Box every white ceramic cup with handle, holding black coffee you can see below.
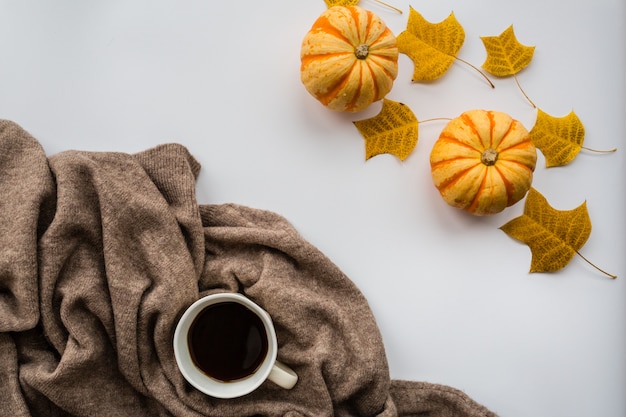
[174,293,298,398]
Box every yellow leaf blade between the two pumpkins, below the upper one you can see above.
[353,99,418,161]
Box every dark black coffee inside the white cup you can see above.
[187,301,267,381]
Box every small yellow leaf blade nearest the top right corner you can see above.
[481,25,535,77]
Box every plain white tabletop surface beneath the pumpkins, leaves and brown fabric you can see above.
[0,0,626,417]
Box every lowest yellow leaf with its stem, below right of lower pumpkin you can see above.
[500,188,616,278]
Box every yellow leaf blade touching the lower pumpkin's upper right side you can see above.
[530,109,585,167]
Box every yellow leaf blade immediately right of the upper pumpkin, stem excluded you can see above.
[398,7,465,82]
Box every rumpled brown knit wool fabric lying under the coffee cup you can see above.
[0,121,495,417]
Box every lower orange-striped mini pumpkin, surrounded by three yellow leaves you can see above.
[430,110,537,216]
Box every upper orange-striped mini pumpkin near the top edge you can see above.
[300,6,398,112]
